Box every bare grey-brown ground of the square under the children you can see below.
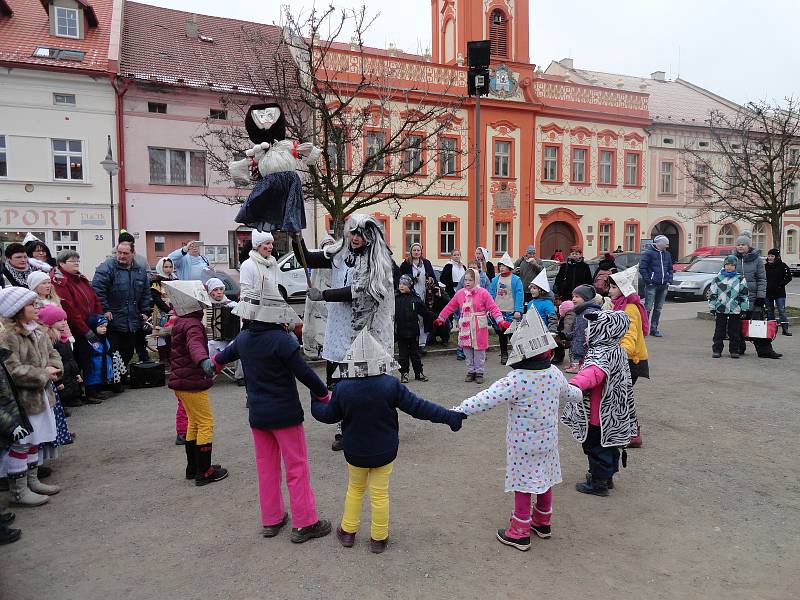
[0,320,800,600]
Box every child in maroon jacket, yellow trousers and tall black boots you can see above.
[164,281,228,486]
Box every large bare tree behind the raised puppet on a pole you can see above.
[195,6,469,237]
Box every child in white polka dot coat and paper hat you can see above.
[454,310,581,551]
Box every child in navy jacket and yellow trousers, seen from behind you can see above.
[311,330,466,554]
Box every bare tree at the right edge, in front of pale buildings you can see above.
[682,98,800,248]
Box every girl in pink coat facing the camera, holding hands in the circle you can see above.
[434,269,510,384]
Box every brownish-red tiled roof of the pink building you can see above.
[119,1,292,95]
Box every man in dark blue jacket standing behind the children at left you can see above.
[92,242,152,365]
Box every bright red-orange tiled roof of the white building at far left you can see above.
[0,0,115,72]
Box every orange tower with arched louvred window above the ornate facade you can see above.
[431,0,530,65]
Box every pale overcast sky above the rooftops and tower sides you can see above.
[145,0,800,102]
